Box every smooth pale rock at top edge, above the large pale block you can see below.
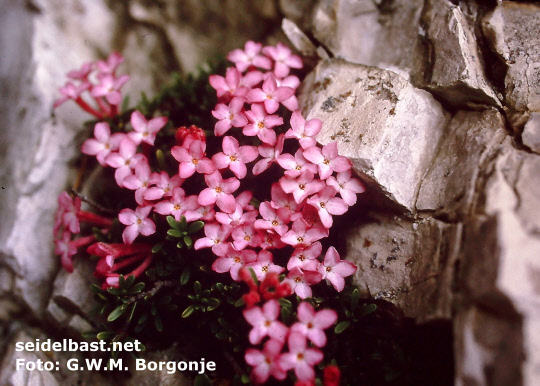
[312,0,428,80]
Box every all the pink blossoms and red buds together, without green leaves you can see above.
[53,42,364,384]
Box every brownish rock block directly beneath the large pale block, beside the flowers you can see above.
[344,215,461,322]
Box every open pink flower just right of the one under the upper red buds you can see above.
[212,137,259,179]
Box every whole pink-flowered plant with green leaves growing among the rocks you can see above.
[50,41,396,385]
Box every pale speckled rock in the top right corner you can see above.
[483,1,540,111]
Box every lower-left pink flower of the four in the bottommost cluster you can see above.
[245,339,287,384]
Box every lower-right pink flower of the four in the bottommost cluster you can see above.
[279,332,323,382]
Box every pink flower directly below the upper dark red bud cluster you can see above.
[171,140,216,178]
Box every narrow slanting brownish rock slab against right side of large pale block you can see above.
[416,110,506,219]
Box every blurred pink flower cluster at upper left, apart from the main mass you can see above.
[54,53,129,119]
